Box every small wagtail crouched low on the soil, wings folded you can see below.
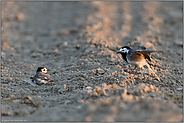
[30,67,50,85]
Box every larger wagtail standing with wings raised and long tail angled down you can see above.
[117,46,160,81]
